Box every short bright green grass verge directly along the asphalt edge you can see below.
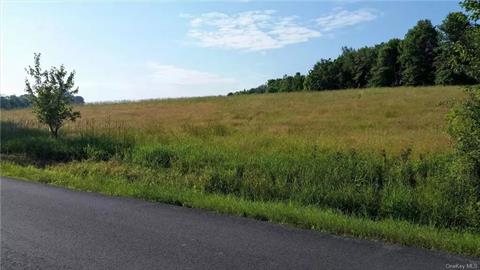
[1,162,480,257]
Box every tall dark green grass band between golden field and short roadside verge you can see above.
[1,123,480,232]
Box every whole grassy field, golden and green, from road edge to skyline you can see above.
[1,87,480,256]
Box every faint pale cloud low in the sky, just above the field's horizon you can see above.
[148,63,235,85]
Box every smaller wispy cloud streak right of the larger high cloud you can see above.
[316,9,378,31]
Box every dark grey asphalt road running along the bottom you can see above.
[0,178,480,270]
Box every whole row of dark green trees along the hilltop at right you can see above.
[228,9,480,95]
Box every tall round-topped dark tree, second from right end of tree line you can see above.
[400,20,438,85]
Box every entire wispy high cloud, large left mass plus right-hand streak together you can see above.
[181,9,378,51]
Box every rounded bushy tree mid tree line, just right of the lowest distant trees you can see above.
[305,59,340,91]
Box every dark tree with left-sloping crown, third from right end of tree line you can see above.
[369,39,401,86]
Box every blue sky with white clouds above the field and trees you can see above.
[0,1,461,102]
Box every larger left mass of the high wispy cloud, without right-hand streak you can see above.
[188,10,321,51]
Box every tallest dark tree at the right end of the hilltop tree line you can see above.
[435,12,475,85]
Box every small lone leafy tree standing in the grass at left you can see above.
[25,53,80,137]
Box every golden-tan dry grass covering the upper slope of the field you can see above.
[1,86,463,153]
